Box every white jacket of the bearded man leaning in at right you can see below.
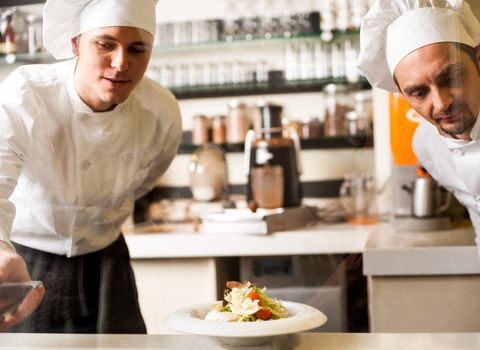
[413,117,480,250]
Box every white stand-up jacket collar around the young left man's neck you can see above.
[67,58,133,118]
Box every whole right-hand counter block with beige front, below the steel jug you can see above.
[363,227,480,332]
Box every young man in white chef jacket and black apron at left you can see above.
[0,0,181,333]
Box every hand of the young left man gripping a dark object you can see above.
[0,241,45,332]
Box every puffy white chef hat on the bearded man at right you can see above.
[357,0,480,91]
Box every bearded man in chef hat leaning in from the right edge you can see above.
[357,0,480,258]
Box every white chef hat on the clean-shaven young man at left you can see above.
[43,0,158,59]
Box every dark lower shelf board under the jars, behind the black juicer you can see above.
[178,131,373,154]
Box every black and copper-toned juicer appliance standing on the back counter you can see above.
[245,104,302,209]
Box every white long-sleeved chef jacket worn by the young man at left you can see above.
[0,59,182,256]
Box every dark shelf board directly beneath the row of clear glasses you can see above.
[170,78,371,100]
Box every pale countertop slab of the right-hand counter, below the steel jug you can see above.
[363,225,480,276]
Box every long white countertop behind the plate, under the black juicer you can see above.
[125,223,372,259]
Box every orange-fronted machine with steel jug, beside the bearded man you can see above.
[389,93,451,231]
